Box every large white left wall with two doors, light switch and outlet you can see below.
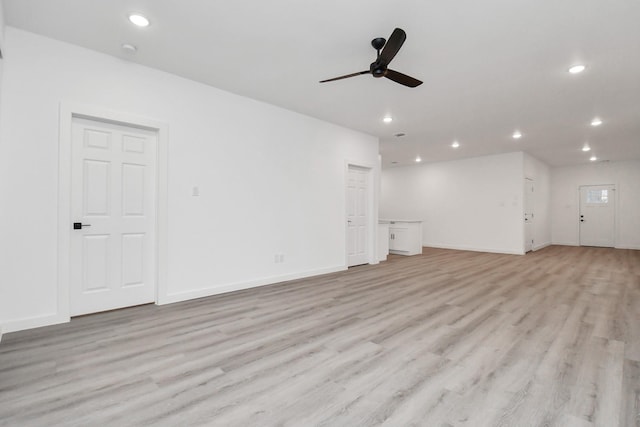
[0,27,379,331]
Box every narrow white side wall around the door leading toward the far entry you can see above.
[524,153,551,250]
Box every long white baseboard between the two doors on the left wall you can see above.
[158,265,347,305]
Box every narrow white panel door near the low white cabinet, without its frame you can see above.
[347,165,369,267]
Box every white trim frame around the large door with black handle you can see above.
[56,102,169,322]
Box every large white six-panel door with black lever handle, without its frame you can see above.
[69,118,157,316]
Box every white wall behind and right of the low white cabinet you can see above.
[380,152,524,254]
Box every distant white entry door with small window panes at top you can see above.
[580,185,615,247]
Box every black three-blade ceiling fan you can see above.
[320,28,422,87]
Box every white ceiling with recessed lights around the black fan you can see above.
[3,0,640,167]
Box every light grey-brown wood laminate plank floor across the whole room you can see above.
[0,246,640,427]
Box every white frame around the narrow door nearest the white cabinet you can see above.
[343,160,380,268]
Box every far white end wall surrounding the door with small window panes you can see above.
[551,160,640,249]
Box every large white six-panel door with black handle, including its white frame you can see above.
[58,102,168,323]
